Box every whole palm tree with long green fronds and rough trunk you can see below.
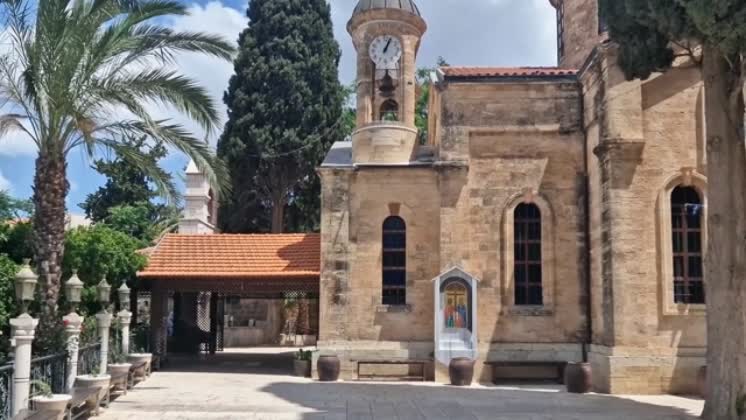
[0,0,234,323]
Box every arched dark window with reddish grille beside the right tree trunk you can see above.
[671,187,705,304]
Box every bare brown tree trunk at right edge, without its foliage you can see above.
[703,46,746,420]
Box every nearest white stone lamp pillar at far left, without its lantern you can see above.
[10,314,39,417]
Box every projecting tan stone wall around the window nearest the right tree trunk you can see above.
[582,47,706,393]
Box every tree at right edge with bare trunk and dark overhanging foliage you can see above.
[601,0,746,420]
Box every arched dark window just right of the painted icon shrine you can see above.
[513,203,544,305]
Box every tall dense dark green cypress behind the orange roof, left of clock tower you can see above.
[218,0,344,232]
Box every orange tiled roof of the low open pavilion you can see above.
[137,234,321,279]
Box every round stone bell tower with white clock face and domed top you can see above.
[347,0,427,165]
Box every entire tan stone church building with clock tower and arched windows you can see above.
[319,0,707,393]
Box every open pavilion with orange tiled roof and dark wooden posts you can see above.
[137,234,320,356]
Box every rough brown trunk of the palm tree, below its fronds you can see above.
[33,150,69,323]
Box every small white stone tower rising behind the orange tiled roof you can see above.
[179,160,217,235]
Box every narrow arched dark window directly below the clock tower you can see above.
[383,216,407,305]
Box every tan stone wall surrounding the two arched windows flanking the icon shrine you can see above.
[319,80,585,381]
